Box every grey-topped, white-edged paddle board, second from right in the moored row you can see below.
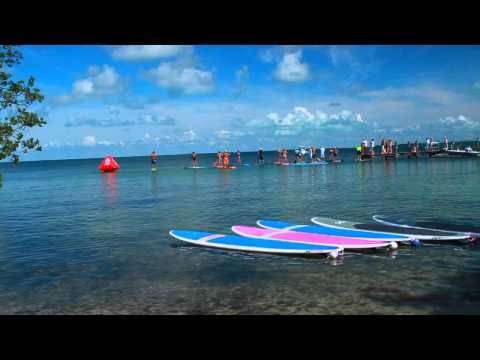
[311,217,470,241]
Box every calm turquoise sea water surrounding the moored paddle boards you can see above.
[0,152,480,314]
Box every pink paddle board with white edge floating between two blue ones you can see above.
[232,225,398,249]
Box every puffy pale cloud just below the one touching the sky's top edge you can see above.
[143,62,214,95]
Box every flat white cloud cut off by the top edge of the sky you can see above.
[110,45,193,61]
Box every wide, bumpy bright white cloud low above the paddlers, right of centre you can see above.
[246,106,366,135]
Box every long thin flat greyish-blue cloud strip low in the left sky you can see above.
[65,114,176,127]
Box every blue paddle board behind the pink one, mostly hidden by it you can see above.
[257,220,410,241]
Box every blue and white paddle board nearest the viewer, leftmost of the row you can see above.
[170,229,343,258]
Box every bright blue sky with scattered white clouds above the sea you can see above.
[6,45,480,160]
